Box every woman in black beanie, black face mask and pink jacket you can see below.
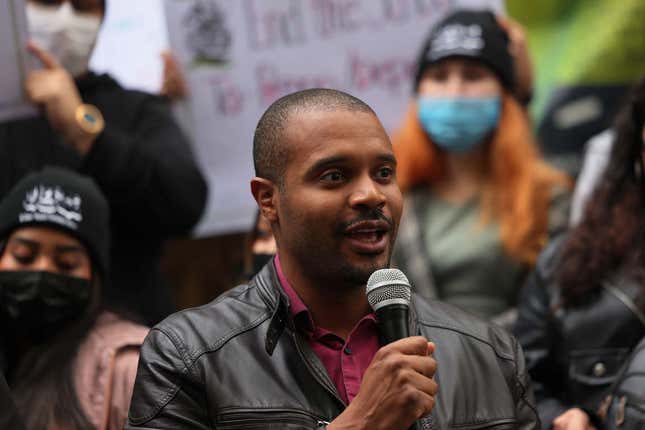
[0,167,148,430]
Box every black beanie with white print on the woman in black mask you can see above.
[0,167,110,276]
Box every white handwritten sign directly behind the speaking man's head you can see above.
[164,0,503,235]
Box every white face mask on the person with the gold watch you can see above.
[27,2,101,77]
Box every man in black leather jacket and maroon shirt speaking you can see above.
[126,89,539,430]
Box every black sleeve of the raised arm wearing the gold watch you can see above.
[81,95,207,236]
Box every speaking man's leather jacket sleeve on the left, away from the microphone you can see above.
[125,328,212,430]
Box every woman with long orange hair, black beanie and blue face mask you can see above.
[393,10,569,323]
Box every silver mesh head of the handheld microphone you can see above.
[366,269,412,312]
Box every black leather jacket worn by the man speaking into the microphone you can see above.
[126,263,539,430]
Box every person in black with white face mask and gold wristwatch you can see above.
[0,0,207,324]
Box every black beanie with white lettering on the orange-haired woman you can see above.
[414,10,515,92]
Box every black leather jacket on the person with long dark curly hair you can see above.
[514,235,645,429]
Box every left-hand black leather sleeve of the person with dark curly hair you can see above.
[514,236,567,429]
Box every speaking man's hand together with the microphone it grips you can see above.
[328,269,438,430]
